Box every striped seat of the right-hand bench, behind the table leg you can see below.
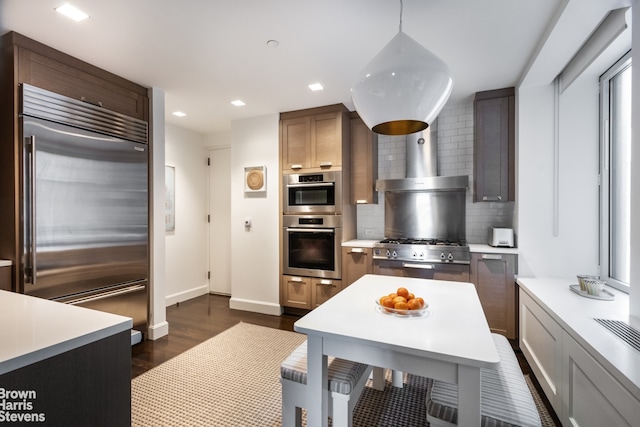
[427,334,541,427]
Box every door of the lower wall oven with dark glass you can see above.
[282,227,342,279]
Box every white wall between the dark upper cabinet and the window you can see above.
[517,72,599,279]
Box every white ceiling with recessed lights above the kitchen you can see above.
[0,0,620,134]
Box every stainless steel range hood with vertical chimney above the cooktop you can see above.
[376,126,469,192]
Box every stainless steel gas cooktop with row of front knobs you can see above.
[373,238,471,264]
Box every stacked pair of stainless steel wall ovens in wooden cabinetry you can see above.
[282,171,342,279]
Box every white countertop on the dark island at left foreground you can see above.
[0,291,133,375]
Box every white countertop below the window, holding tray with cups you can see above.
[517,277,640,399]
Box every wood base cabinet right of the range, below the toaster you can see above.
[469,253,517,339]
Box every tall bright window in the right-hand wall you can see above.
[600,52,631,292]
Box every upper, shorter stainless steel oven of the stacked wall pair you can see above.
[282,172,342,214]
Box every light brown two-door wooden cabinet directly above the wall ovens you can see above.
[280,104,349,174]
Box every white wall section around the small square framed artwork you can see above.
[230,114,281,315]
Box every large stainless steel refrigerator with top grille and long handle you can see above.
[20,84,149,330]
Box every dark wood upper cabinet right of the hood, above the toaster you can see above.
[473,88,515,202]
